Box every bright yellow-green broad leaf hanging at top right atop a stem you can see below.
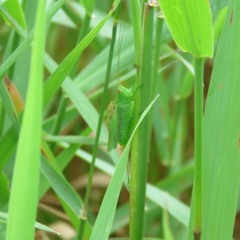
[159,0,213,58]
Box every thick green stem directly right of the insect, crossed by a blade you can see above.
[130,5,153,239]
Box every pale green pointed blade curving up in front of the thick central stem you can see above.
[90,96,158,240]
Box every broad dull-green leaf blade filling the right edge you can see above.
[189,0,240,240]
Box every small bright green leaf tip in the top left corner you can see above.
[1,0,26,29]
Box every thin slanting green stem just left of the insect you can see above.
[78,7,119,240]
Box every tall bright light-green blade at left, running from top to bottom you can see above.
[7,0,45,240]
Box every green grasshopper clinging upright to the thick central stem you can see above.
[107,85,134,150]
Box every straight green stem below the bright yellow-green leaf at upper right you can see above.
[193,59,204,240]
